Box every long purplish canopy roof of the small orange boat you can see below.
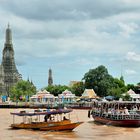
[10,109,72,116]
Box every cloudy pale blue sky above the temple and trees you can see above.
[0,0,140,89]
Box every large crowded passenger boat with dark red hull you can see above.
[88,101,140,127]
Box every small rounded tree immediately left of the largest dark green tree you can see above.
[71,82,85,96]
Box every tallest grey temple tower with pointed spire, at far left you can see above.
[0,24,22,96]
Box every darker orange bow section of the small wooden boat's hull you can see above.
[40,122,83,131]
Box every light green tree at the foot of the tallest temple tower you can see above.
[10,80,36,101]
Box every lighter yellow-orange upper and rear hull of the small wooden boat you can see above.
[11,120,71,129]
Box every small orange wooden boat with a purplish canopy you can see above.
[11,109,83,131]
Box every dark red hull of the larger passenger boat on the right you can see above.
[93,116,140,127]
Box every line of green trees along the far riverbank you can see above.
[10,65,140,100]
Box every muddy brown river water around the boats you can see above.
[0,109,140,140]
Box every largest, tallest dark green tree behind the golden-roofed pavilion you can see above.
[83,65,113,96]
